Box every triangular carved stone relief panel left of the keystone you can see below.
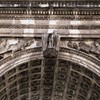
[0,38,42,59]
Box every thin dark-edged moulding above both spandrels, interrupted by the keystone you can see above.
[0,32,100,40]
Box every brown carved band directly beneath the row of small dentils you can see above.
[0,14,100,21]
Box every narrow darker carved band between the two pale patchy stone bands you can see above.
[0,24,100,30]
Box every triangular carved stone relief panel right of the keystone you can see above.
[60,39,100,59]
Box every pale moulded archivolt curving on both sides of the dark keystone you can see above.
[0,48,100,76]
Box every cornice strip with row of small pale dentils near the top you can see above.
[0,8,100,16]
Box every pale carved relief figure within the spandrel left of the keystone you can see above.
[0,39,33,54]
